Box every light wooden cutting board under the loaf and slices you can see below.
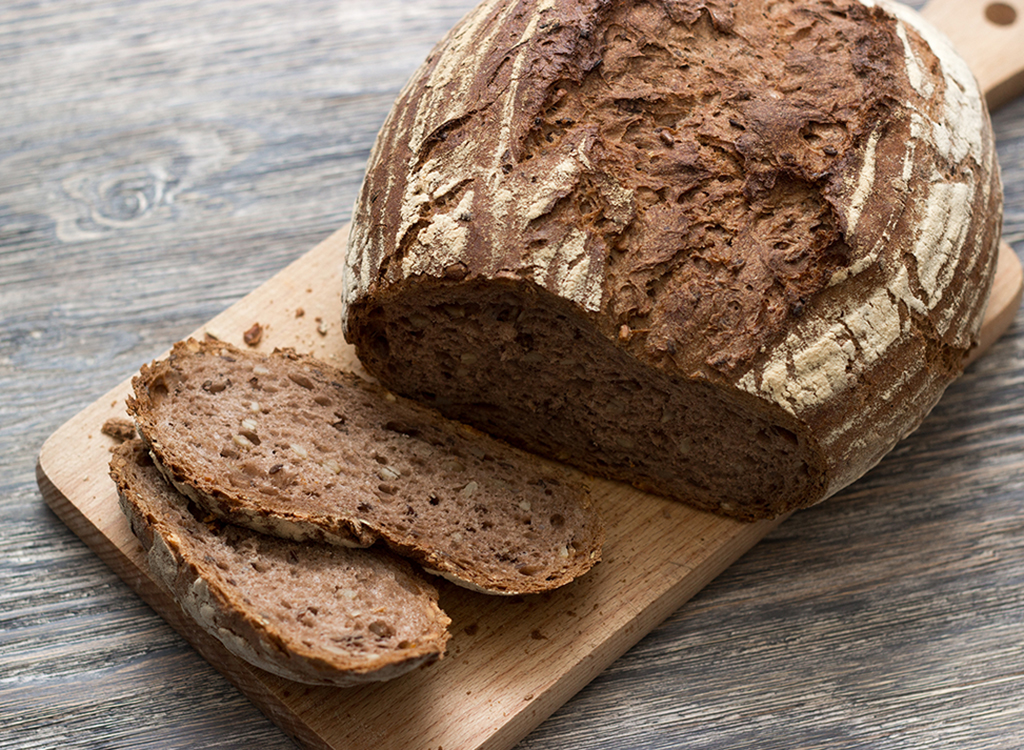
[37,0,1024,750]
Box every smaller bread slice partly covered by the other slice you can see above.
[111,439,451,686]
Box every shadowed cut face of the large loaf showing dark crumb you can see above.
[352,283,825,518]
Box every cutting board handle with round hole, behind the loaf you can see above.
[921,0,1024,110]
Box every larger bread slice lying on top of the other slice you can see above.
[128,340,604,594]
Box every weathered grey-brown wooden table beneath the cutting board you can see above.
[0,0,1024,750]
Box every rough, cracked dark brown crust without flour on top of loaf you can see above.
[515,1,901,373]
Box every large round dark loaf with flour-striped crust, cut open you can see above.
[344,0,1001,519]
